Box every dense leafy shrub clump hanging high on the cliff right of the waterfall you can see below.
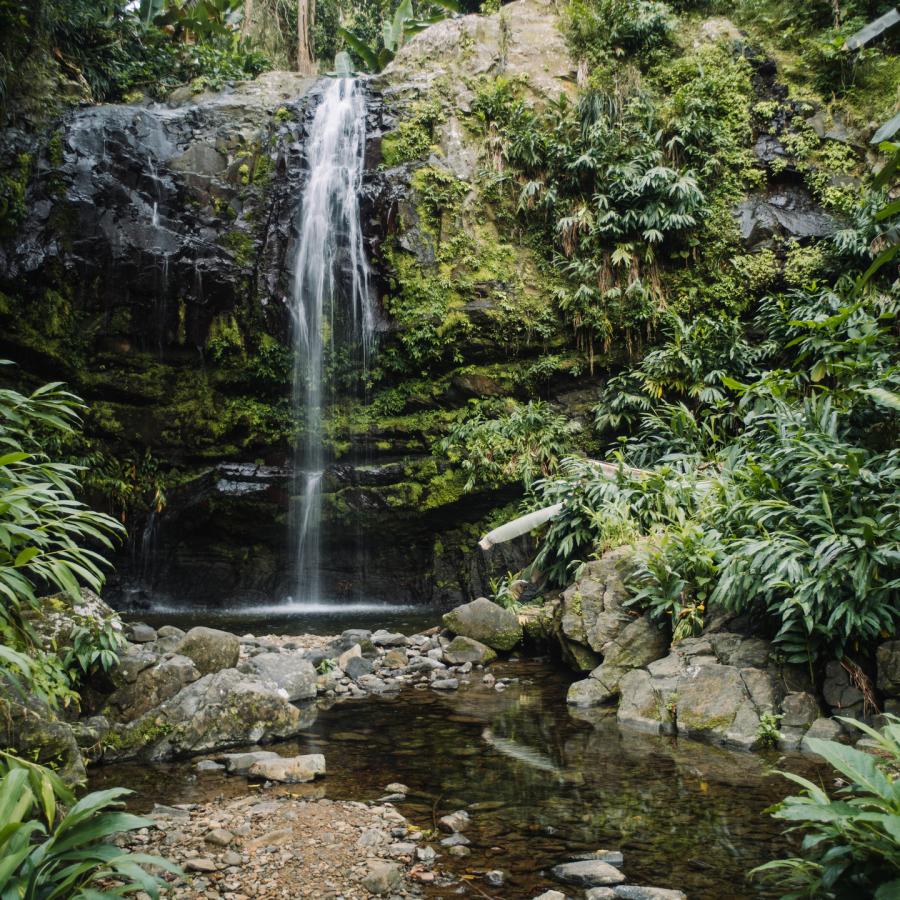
[474,82,704,360]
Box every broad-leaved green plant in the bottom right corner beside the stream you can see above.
[750,715,900,900]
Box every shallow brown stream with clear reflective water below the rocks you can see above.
[92,614,816,900]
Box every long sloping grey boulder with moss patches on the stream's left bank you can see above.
[104,669,315,761]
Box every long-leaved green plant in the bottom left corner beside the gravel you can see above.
[0,753,179,900]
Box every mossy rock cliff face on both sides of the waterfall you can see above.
[0,0,840,605]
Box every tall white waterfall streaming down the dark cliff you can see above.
[291,78,374,604]
